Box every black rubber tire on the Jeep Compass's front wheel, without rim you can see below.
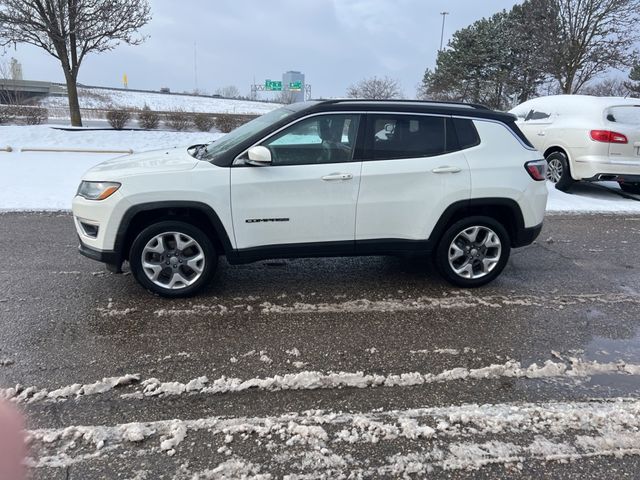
[129,221,218,298]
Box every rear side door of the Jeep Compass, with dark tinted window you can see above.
[356,113,471,241]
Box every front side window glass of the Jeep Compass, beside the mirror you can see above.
[262,114,360,165]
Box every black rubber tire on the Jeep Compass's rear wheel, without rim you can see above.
[434,216,511,288]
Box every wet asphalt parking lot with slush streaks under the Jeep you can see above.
[0,213,640,480]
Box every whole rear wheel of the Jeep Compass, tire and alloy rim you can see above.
[435,216,511,288]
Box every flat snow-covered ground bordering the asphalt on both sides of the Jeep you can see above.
[0,125,640,213]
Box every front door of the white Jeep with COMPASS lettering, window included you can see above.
[231,114,361,249]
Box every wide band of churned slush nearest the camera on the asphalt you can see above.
[27,399,640,480]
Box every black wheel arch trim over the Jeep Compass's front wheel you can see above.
[114,201,233,262]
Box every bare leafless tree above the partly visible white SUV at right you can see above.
[548,0,640,93]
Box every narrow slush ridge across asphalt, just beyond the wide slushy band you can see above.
[5,358,640,403]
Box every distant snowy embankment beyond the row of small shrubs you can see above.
[40,88,281,114]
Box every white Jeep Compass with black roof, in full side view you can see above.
[73,100,547,297]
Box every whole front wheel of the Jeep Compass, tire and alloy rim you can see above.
[129,221,218,298]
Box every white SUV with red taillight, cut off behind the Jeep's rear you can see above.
[511,95,640,194]
